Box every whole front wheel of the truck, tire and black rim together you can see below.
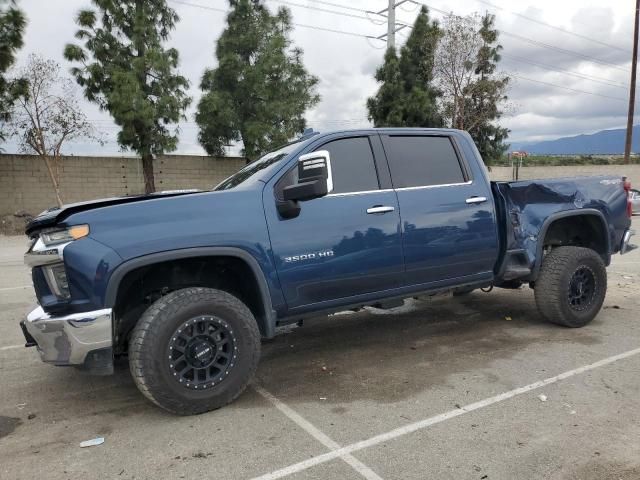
[129,288,260,415]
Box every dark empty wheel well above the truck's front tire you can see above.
[114,256,266,353]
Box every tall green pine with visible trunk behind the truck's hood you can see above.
[64,0,191,193]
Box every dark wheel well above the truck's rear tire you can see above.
[543,215,609,263]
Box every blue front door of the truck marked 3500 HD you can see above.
[264,135,404,313]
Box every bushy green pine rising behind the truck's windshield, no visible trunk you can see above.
[196,0,320,160]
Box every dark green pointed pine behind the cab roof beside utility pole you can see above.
[367,6,442,127]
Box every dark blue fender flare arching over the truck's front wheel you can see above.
[105,247,276,338]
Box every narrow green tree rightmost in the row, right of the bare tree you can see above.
[465,13,509,163]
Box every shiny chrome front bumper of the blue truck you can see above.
[22,307,113,374]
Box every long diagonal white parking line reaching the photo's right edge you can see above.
[253,348,640,480]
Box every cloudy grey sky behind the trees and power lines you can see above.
[4,0,634,155]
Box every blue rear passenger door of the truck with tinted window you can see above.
[382,134,498,285]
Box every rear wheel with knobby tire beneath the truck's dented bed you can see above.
[535,247,607,328]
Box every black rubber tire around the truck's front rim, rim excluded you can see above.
[129,287,260,415]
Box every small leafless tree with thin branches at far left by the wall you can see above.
[11,54,102,206]
